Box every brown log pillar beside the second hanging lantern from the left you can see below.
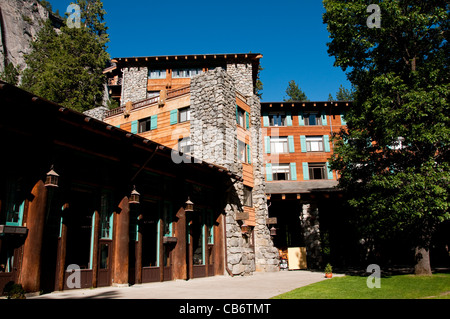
[113,196,130,286]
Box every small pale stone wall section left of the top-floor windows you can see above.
[121,67,148,105]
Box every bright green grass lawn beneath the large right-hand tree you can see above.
[273,274,450,299]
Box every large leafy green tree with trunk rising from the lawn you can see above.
[323,0,450,274]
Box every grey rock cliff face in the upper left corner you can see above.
[0,0,49,72]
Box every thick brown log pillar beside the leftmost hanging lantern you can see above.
[20,180,47,292]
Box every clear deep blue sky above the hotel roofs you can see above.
[50,0,350,102]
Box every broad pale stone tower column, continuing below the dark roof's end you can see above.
[190,68,255,275]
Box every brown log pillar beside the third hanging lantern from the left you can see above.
[172,207,187,280]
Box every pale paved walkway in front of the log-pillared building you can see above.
[28,270,340,299]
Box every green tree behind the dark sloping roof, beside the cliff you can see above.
[22,0,109,112]
